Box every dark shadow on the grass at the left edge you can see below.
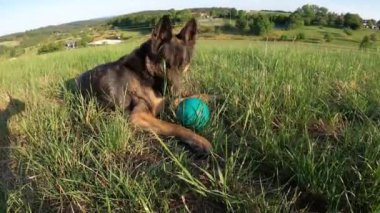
[0,96,25,212]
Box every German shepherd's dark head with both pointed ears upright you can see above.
[146,16,197,93]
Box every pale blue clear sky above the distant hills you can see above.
[0,0,380,35]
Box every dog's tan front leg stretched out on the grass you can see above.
[130,102,211,153]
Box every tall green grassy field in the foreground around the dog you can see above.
[0,41,380,212]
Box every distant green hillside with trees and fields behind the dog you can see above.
[0,5,380,59]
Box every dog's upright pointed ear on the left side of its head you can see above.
[152,15,172,50]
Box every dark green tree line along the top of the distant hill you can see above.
[108,4,380,35]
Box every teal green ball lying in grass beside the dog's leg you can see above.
[176,98,210,131]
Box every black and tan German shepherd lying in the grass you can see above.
[76,16,211,153]
